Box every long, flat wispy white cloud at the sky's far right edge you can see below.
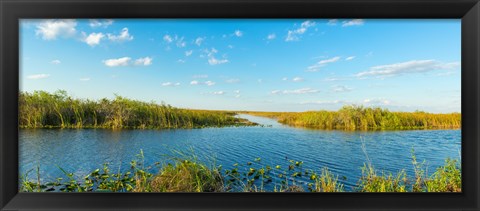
[356,60,460,77]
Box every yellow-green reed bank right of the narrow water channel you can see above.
[244,106,461,130]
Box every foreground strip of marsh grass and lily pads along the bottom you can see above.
[19,149,462,192]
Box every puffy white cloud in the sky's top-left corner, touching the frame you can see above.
[35,19,77,40]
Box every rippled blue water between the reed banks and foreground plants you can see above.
[19,115,461,190]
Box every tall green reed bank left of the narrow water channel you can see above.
[19,91,254,129]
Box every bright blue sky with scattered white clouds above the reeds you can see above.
[20,19,461,113]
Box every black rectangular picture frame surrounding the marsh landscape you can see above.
[0,0,480,210]
